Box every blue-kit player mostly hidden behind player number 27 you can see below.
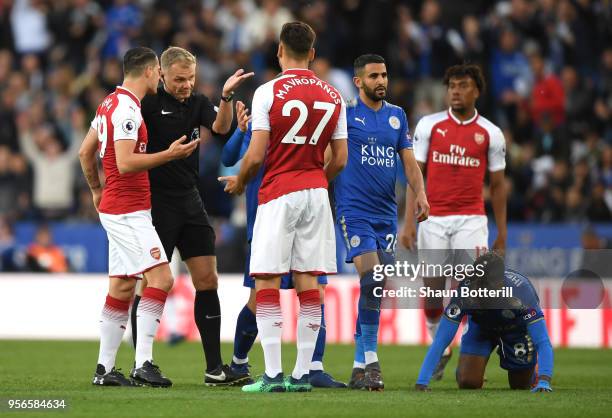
[221,102,346,388]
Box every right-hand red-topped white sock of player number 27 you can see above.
[291,289,321,379]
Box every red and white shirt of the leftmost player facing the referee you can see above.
[91,86,151,215]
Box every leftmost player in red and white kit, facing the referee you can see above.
[79,47,197,387]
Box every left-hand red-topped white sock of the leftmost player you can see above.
[98,295,130,372]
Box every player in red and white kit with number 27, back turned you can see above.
[221,22,348,392]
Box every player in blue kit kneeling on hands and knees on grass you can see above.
[415,252,553,392]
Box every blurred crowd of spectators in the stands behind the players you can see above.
[0,0,612,247]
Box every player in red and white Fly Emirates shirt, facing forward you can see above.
[400,64,506,379]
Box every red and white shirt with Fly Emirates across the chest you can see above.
[413,109,506,216]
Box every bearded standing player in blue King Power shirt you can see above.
[334,54,429,391]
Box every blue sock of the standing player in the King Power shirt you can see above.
[359,271,384,365]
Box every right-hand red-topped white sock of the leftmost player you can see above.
[136,287,168,368]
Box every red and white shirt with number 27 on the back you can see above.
[252,69,348,205]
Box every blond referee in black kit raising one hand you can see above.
[132,47,253,386]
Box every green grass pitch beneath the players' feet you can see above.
[0,340,612,418]
